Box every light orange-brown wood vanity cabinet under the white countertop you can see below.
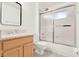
[0,35,33,57]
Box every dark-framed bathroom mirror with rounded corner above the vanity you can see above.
[1,2,22,26]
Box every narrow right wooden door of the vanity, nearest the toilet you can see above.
[24,43,33,57]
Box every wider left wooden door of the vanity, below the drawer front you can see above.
[3,47,23,57]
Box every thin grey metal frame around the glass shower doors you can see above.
[39,4,76,47]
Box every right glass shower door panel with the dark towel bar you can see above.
[54,6,76,46]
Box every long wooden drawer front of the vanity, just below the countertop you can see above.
[3,36,33,50]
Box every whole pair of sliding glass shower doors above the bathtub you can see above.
[40,5,76,47]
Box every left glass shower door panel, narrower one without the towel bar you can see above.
[40,12,53,42]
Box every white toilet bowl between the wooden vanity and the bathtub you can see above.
[35,41,47,55]
